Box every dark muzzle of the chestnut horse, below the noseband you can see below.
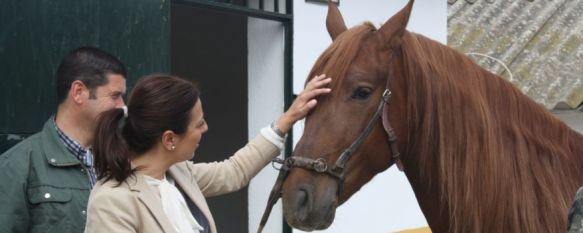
[282,174,338,231]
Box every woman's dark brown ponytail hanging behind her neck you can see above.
[93,109,132,185]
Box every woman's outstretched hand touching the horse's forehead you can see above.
[276,74,332,134]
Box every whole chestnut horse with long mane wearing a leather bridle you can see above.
[281,0,583,233]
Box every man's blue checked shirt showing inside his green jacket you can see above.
[53,120,97,187]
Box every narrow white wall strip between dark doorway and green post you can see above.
[247,18,284,233]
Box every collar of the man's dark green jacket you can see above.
[41,118,81,167]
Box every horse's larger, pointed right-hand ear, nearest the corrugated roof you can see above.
[379,0,415,46]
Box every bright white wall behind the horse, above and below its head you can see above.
[292,0,447,233]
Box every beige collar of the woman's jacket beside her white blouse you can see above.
[125,173,176,232]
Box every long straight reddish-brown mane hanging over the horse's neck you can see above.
[396,32,583,232]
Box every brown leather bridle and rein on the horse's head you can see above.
[257,88,402,233]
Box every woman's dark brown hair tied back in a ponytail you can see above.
[93,74,199,183]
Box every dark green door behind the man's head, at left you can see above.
[0,0,170,154]
